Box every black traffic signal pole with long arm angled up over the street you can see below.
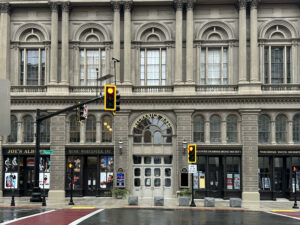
[30,95,103,202]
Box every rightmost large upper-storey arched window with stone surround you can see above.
[260,20,297,84]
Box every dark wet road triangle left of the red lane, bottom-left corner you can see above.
[0,208,47,223]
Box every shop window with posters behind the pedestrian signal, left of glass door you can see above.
[66,156,82,190]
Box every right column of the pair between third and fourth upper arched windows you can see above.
[186,0,194,83]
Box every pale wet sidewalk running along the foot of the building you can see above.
[0,197,300,211]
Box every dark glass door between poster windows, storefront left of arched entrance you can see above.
[84,156,97,196]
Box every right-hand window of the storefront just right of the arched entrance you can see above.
[226,156,241,190]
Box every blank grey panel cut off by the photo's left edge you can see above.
[0,79,10,136]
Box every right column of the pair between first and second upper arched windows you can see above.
[61,2,70,85]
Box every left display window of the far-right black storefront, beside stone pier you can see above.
[258,156,271,191]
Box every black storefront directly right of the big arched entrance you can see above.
[193,149,242,199]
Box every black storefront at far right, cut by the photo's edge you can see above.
[258,150,300,200]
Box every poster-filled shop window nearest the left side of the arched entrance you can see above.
[100,156,114,189]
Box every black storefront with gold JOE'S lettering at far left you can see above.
[2,148,51,196]
